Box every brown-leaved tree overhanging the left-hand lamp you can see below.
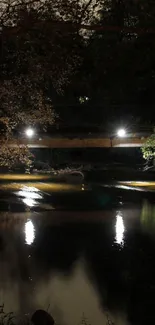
[0,0,99,165]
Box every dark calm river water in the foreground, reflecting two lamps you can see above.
[0,184,155,325]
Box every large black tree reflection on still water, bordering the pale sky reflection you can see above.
[34,213,155,324]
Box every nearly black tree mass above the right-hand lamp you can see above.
[60,0,155,123]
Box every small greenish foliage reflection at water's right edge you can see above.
[141,200,155,233]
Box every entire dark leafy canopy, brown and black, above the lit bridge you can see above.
[0,0,155,164]
